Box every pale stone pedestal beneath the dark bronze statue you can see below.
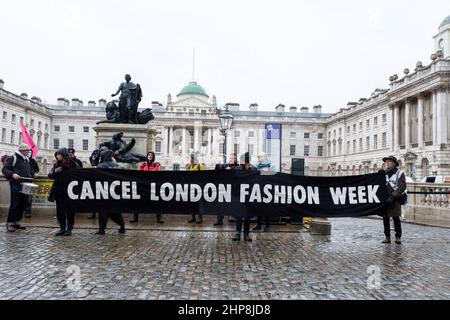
[94,123,159,169]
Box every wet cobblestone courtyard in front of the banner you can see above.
[0,217,450,299]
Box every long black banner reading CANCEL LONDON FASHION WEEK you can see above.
[54,169,387,217]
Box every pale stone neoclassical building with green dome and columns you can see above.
[0,16,450,180]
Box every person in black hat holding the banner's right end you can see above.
[380,156,406,244]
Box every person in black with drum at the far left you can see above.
[2,144,37,232]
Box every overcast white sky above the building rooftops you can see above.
[0,0,450,112]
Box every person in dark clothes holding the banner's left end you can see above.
[48,148,78,237]
